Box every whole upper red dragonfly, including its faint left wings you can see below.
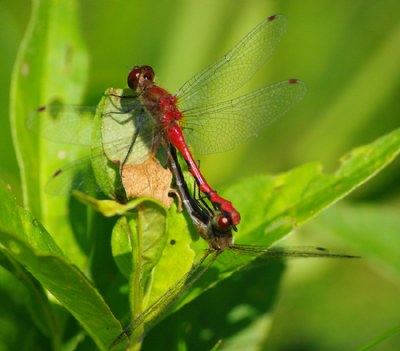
[32,15,306,230]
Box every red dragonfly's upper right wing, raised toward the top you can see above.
[176,15,287,112]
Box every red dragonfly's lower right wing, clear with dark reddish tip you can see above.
[184,79,307,154]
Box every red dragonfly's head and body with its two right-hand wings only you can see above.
[128,15,305,226]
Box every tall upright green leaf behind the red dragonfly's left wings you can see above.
[11,0,88,268]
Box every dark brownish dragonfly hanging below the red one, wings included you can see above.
[111,145,359,348]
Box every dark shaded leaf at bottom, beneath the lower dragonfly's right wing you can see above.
[144,260,285,350]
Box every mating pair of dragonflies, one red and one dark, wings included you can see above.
[34,15,353,346]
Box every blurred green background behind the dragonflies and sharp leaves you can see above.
[0,0,400,350]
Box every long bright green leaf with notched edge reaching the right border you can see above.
[170,129,400,314]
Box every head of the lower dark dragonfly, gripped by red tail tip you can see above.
[207,211,233,250]
